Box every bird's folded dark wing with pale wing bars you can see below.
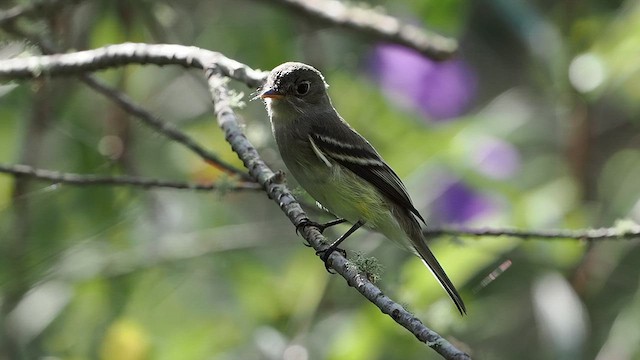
[309,119,425,223]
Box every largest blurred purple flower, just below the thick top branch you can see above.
[370,45,477,120]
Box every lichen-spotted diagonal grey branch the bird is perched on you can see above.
[206,68,470,359]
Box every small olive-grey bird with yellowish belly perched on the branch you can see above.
[258,62,466,315]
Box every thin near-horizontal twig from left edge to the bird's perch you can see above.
[0,164,261,191]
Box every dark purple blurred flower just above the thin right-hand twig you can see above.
[431,180,496,224]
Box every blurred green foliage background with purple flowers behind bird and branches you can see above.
[0,0,640,360]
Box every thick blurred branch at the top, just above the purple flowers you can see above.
[263,0,458,60]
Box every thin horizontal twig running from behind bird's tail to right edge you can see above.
[424,225,640,241]
